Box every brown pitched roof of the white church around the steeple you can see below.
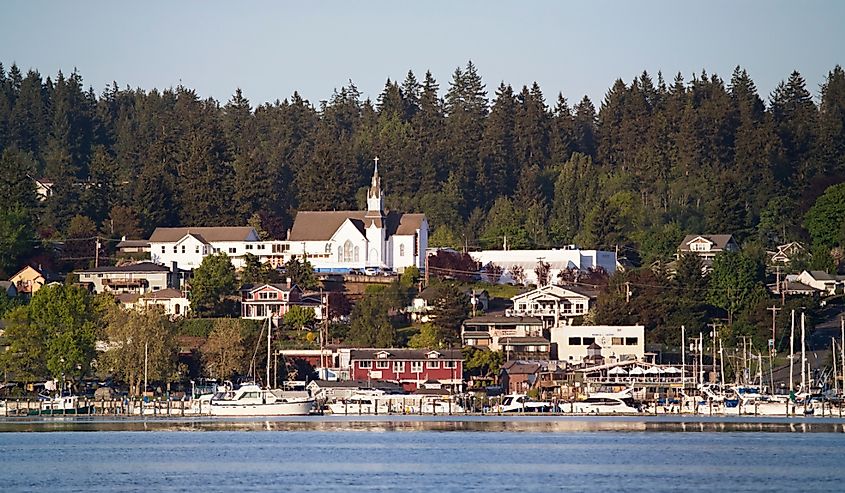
[288,211,425,241]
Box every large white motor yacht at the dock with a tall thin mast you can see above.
[206,317,315,416]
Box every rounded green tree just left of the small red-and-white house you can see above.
[191,252,235,316]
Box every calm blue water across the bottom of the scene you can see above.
[0,418,845,492]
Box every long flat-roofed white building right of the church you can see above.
[468,245,617,285]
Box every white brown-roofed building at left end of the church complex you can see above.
[150,226,258,270]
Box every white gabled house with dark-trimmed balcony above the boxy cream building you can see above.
[505,284,598,328]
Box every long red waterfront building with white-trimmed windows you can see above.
[349,348,464,391]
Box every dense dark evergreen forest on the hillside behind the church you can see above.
[0,62,845,270]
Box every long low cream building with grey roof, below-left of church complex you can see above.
[76,262,187,294]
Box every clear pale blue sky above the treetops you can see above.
[0,0,845,106]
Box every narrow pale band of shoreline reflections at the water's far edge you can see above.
[0,416,845,433]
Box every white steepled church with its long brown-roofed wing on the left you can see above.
[150,158,428,272]
